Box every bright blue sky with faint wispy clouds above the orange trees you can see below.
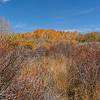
[0,0,100,32]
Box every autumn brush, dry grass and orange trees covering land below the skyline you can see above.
[0,30,100,100]
